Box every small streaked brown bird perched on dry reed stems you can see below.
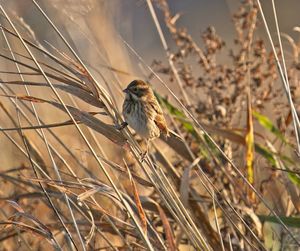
[123,80,169,156]
